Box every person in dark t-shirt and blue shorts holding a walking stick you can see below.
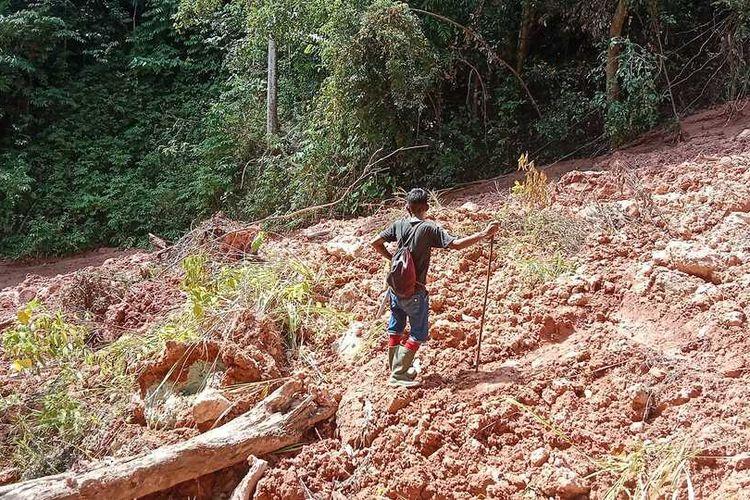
[371,188,499,387]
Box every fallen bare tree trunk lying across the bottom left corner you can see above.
[0,378,336,500]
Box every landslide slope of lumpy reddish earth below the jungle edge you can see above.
[0,101,750,499]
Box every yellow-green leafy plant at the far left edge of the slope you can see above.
[2,300,86,371]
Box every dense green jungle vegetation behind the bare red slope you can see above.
[0,0,750,257]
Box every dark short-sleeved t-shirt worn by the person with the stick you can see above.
[380,217,456,290]
